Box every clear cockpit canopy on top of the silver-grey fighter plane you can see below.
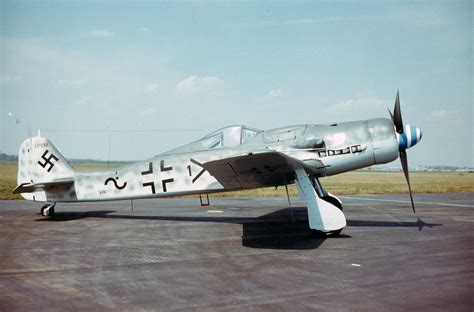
[161,125,262,154]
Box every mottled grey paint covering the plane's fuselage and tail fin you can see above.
[18,118,398,202]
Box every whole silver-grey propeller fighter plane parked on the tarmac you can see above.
[13,92,422,235]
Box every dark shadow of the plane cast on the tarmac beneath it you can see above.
[36,207,442,250]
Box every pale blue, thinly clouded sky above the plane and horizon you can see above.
[0,1,474,166]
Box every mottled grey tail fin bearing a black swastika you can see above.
[14,133,74,199]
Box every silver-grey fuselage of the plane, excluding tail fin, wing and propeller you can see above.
[45,118,399,202]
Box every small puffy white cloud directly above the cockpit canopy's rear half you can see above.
[176,76,224,96]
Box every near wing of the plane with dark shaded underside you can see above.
[202,150,325,189]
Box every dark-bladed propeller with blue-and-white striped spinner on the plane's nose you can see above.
[388,90,423,213]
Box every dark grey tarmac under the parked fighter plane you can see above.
[0,193,474,311]
